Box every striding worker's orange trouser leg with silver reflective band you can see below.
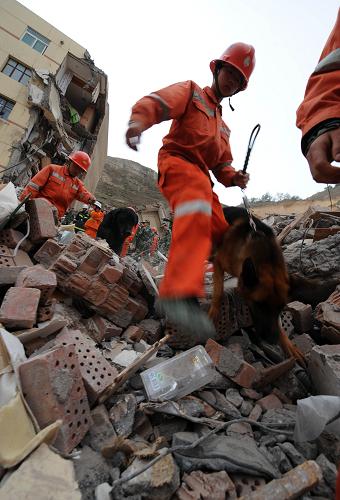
[159,157,227,298]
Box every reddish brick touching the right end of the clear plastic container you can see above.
[205,339,257,389]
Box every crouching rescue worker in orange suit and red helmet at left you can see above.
[20,151,96,219]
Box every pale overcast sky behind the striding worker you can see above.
[21,0,339,204]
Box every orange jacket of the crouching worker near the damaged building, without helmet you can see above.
[20,164,94,218]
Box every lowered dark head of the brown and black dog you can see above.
[239,235,289,343]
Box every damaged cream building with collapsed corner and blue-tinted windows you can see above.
[0,0,109,191]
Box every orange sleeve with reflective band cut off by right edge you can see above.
[296,10,340,144]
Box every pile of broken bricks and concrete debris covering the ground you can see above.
[0,199,340,500]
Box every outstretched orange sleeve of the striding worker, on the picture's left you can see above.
[129,80,193,130]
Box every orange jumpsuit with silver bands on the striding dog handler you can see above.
[130,80,235,298]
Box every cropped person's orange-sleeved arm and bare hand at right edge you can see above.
[296,10,340,184]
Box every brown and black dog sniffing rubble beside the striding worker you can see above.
[209,207,303,362]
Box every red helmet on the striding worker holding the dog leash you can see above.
[210,42,255,90]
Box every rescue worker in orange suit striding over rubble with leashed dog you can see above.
[126,43,255,342]
